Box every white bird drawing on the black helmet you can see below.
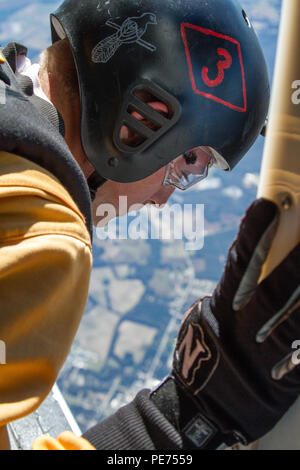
[92,13,157,64]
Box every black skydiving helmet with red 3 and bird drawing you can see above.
[51,0,270,182]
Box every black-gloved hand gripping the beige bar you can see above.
[151,199,300,449]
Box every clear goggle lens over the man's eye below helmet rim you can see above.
[163,147,215,190]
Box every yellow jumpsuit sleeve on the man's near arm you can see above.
[0,152,92,446]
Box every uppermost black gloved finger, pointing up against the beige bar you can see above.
[220,198,278,310]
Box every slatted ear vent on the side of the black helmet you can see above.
[114,80,180,153]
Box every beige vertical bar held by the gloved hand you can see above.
[258,0,300,279]
